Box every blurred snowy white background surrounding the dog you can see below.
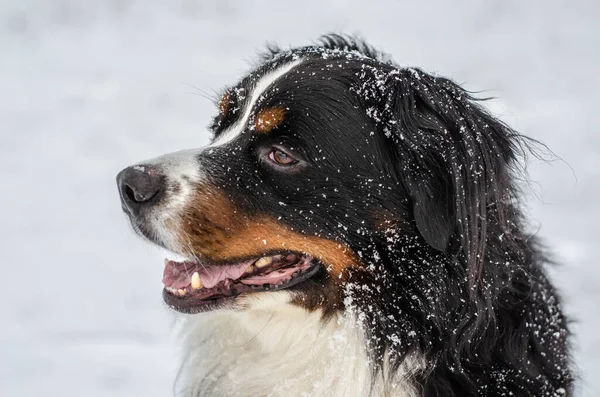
[0,0,600,397]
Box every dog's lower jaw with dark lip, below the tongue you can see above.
[162,265,322,314]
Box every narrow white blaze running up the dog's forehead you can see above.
[210,59,302,147]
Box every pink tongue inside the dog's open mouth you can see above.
[163,260,254,289]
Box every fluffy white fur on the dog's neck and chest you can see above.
[177,292,422,397]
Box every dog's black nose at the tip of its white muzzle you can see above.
[117,165,164,215]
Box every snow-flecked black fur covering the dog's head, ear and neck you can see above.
[223,36,572,397]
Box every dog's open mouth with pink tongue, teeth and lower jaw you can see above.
[163,253,320,313]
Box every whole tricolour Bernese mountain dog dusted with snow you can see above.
[117,35,574,397]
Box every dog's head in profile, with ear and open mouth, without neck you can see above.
[117,36,516,313]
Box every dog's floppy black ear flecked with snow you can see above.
[368,68,519,282]
